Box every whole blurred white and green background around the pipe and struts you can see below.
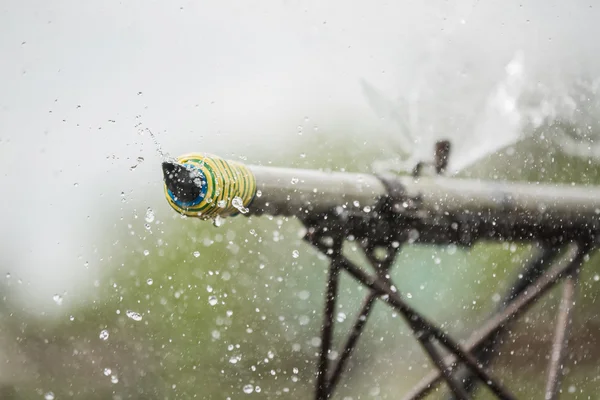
[0,0,600,400]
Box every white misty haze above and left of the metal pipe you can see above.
[0,0,600,311]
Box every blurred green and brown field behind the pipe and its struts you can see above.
[0,123,600,400]
